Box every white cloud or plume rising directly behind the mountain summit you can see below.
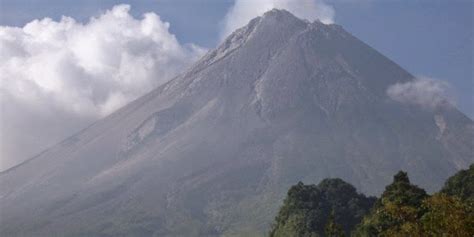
[222,0,335,37]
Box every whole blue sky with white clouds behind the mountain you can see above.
[0,0,474,171]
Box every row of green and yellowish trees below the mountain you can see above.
[269,164,474,237]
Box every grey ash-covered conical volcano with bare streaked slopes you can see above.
[0,10,474,236]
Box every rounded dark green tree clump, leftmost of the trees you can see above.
[270,179,375,236]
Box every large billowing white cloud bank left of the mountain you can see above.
[0,5,204,170]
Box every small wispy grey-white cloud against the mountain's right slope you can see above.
[387,77,455,108]
